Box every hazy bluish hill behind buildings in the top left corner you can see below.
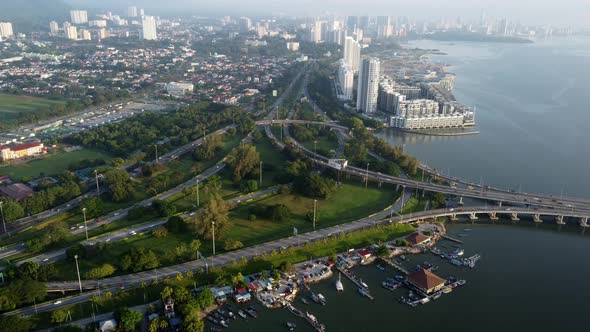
[0,0,70,33]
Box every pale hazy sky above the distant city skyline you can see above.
[67,0,590,26]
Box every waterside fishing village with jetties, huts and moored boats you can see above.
[201,223,481,331]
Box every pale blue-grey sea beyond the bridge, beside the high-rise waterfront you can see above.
[380,39,590,197]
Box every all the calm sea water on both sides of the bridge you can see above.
[212,39,590,332]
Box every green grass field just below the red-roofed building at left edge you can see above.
[0,149,113,179]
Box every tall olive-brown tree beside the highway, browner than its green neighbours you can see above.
[196,194,230,239]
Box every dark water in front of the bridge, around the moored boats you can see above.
[220,223,590,331]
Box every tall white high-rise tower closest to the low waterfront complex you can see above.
[356,57,380,113]
